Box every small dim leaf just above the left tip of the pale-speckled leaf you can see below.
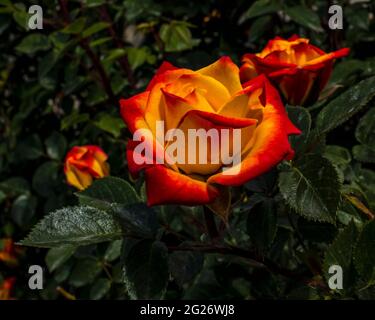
[12,194,37,227]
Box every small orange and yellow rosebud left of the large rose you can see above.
[64,145,109,190]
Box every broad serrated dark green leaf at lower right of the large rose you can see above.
[279,155,340,223]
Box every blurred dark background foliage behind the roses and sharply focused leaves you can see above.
[0,0,375,299]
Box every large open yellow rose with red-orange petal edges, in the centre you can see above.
[120,57,300,205]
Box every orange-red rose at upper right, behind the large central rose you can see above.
[240,35,349,105]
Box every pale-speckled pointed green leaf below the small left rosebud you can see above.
[21,207,122,248]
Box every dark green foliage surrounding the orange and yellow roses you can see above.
[0,0,375,299]
